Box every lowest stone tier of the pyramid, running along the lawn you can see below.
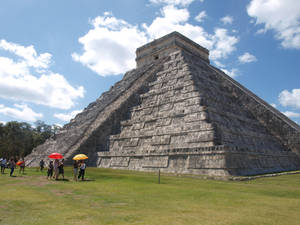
[97,145,300,176]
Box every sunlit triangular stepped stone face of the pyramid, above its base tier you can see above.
[110,51,218,156]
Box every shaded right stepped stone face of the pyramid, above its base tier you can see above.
[186,51,288,151]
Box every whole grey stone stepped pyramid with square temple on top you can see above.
[26,32,300,176]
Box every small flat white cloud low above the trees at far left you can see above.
[0,104,43,122]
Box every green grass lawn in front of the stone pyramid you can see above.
[0,167,300,225]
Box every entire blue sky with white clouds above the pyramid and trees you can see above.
[0,0,300,125]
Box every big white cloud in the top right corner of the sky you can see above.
[247,0,300,49]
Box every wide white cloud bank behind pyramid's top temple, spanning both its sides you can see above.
[72,5,238,76]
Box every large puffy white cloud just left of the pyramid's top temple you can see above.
[72,13,147,76]
